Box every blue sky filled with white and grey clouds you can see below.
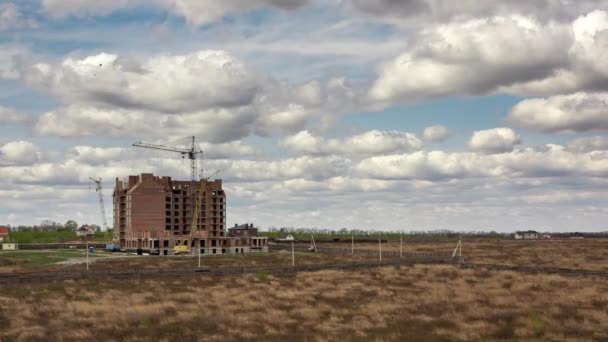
[0,0,608,232]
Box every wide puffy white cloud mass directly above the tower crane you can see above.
[25,50,342,143]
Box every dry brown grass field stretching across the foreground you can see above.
[0,240,608,341]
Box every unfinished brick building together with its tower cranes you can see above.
[85,137,268,255]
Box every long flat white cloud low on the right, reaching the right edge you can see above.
[356,145,608,180]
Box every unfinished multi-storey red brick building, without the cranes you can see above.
[113,173,268,255]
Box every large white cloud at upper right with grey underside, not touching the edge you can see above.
[370,16,573,101]
